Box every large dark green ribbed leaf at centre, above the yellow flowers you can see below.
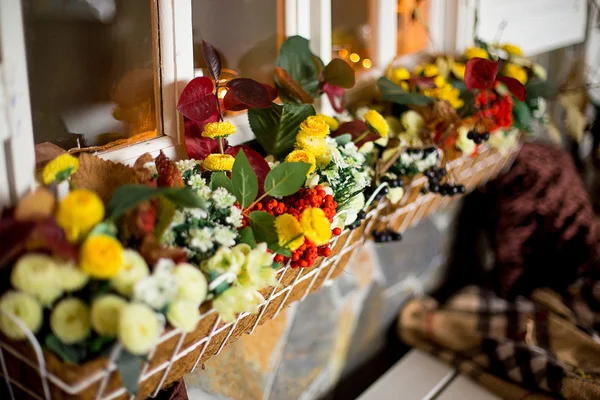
[248,104,316,158]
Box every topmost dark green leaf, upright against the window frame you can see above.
[277,36,320,97]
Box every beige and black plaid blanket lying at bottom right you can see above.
[398,280,600,400]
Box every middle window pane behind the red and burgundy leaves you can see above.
[192,0,283,84]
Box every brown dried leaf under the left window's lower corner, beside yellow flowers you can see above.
[71,153,139,204]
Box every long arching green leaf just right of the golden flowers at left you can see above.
[107,185,204,220]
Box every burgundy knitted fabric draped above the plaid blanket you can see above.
[487,144,599,297]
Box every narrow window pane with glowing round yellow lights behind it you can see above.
[331,0,373,71]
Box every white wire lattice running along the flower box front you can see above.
[0,145,519,400]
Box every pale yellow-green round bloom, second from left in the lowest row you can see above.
[50,297,91,344]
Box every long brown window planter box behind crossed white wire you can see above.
[0,145,518,400]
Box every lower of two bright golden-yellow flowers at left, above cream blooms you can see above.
[79,235,123,279]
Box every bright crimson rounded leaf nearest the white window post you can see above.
[177,76,217,122]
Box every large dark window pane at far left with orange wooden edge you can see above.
[24,0,157,154]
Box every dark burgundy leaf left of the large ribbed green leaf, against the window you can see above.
[223,78,271,111]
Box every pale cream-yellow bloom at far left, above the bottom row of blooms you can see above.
[10,253,63,306]
